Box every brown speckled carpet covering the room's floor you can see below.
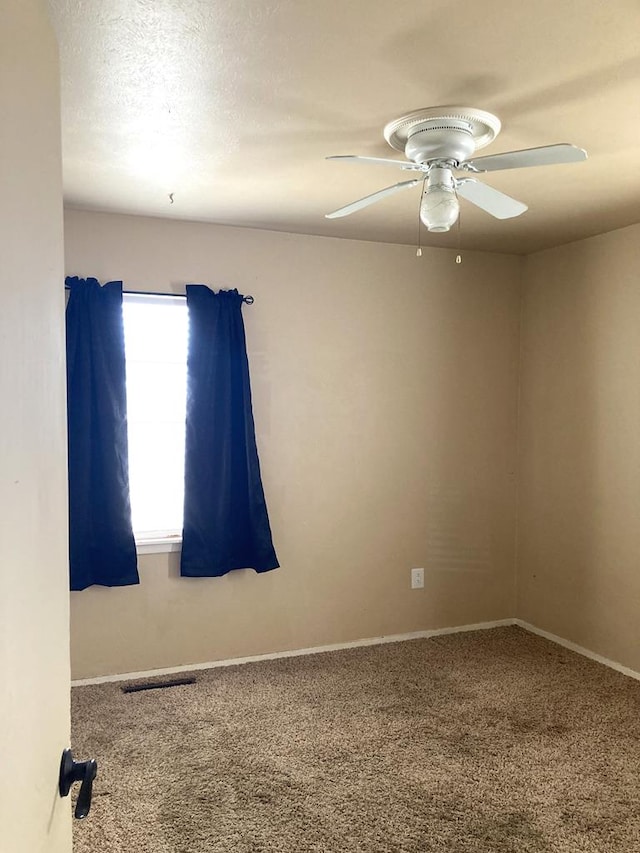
[72,628,640,853]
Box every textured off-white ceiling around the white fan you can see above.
[50,0,640,253]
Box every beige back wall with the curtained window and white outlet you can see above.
[65,211,521,678]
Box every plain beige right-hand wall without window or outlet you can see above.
[517,225,640,671]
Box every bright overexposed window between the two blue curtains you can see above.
[123,294,188,544]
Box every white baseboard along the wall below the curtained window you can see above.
[71,619,525,687]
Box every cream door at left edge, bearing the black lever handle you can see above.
[0,0,71,853]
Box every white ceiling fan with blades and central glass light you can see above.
[326,107,587,232]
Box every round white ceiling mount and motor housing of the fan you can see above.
[383,107,501,165]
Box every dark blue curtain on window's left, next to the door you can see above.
[66,277,139,590]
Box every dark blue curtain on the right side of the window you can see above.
[181,284,278,577]
